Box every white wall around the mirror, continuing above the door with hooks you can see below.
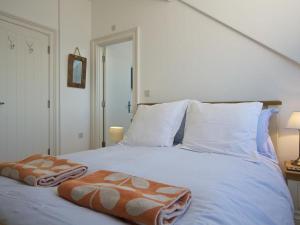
[0,0,91,153]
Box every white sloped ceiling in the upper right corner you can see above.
[179,0,300,64]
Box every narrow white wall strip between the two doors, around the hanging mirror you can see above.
[60,0,91,153]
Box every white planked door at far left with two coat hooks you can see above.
[0,18,49,161]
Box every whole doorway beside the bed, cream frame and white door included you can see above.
[91,28,139,148]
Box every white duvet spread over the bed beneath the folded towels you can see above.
[0,145,294,225]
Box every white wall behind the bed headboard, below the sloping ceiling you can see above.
[92,0,300,164]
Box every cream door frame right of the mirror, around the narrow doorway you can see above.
[90,27,140,149]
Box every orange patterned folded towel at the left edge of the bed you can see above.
[0,154,87,187]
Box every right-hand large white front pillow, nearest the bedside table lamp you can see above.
[182,101,262,158]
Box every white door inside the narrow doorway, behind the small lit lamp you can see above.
[104,41,132,146]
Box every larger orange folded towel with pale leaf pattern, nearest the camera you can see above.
[58,170,191,225]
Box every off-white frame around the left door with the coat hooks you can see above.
[0,10,60,155]
